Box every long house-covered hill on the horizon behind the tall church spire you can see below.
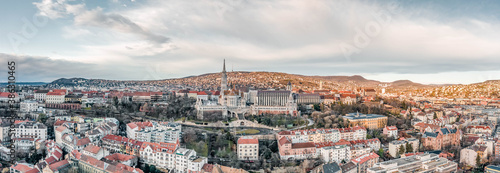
[48,71,429,90]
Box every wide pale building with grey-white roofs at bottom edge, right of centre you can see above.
[367,153,458,173]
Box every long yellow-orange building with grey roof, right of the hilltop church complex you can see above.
[343,113,387,129]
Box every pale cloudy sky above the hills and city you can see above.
[0,0,500,84]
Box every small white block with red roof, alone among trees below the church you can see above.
[237,136,259,160]
